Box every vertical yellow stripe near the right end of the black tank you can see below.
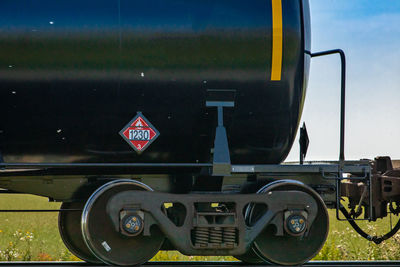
[271,0,283,81]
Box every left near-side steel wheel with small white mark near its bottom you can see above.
[82,180,165,266]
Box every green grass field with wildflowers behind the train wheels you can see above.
[0,195,400,261]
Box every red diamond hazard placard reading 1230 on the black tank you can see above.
[119,112,160,154]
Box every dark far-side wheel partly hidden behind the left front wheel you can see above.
[58,202,101,263]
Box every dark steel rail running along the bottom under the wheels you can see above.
[0,261,400,267]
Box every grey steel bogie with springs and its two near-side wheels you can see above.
[76,180,328,265]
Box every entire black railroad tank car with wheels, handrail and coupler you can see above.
[0,0,400,266]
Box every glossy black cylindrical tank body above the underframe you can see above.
[0,0,310,164]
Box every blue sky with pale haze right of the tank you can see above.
[287,0,400,161]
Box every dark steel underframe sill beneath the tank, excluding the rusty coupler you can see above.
[0,161,371,202]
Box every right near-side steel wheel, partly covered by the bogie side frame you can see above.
[246,180,329,265]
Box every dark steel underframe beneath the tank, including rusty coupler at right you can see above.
[0,157,400,220]
